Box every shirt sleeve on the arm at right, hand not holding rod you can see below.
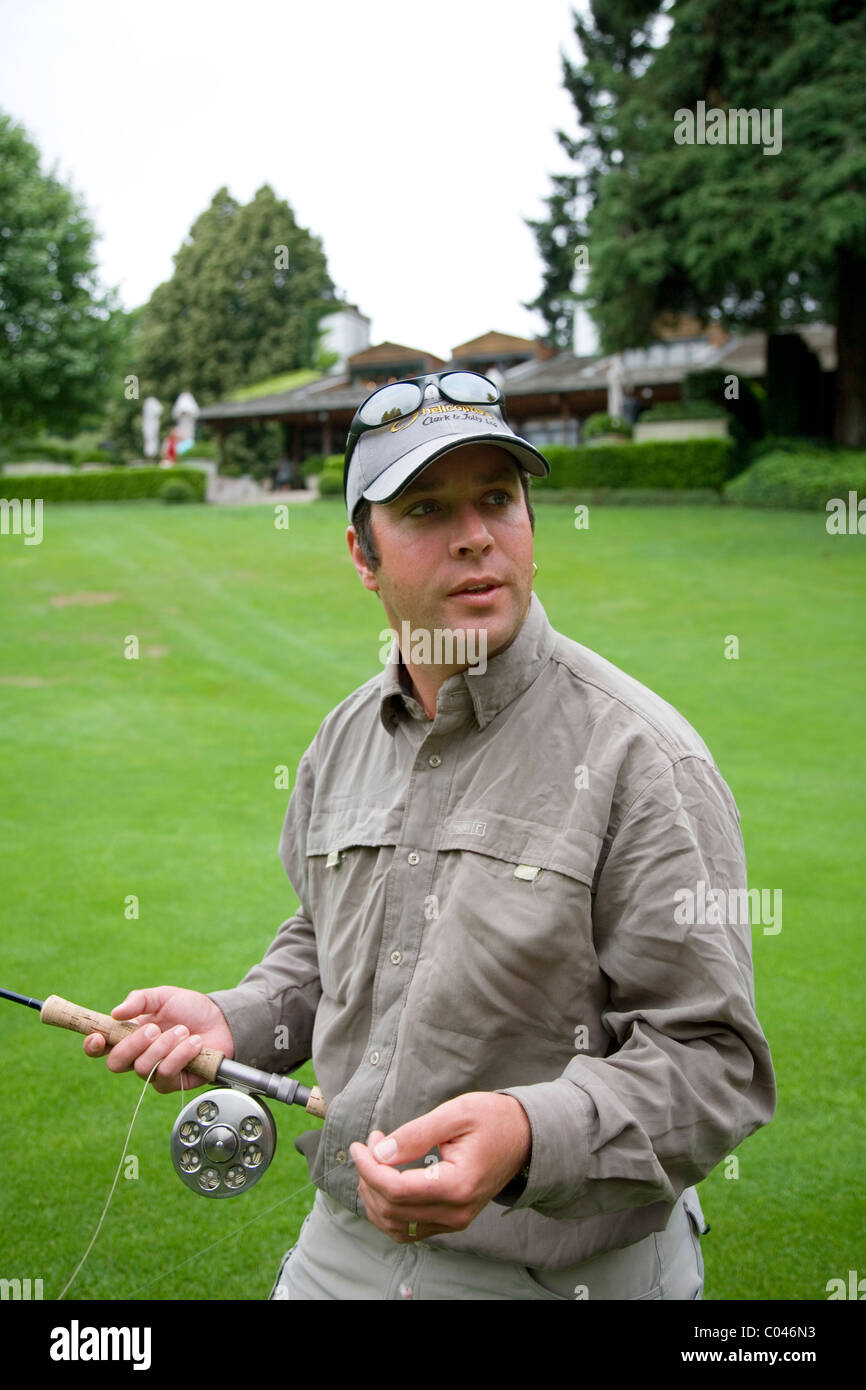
[494,756,776,1219]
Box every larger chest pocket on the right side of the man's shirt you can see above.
[421,810,607,1054]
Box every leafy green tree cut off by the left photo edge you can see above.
[0,113,124,438]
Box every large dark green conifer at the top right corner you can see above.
[530,0,866,445]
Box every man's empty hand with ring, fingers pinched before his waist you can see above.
[349,1091,532,1244]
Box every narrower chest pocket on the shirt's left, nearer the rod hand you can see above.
[304,805,402,1004]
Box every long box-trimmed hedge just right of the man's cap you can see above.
[532,439,734,491]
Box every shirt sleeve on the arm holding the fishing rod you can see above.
[210,749,321,1072]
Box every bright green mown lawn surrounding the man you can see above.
[0,500,866,1300]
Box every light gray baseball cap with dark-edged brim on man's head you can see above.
[346,384,550,521]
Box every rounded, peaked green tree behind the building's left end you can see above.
[138,185,334,404]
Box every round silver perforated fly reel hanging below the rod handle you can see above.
[171,1087,277,1197]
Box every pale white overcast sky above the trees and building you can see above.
[0,0,603,357]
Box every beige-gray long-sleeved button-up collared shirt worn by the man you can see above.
[213,595,776,1269]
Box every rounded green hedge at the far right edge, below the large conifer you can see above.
[724,448,866,512]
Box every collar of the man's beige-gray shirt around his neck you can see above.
[379,592,556,734]
